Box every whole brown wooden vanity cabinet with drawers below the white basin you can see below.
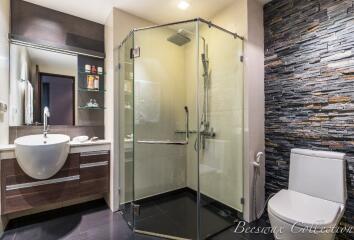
[1,151,110,214]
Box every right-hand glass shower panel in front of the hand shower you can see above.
[196,22,243,236]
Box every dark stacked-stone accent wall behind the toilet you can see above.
[264,0,354,239]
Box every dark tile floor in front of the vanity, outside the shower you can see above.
[1,200,156,240]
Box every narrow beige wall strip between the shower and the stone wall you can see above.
[244,0,265,221]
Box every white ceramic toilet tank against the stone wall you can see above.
[289,148,347,204]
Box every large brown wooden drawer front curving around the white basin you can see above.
[1,154,80,214]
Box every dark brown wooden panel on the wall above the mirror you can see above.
[11,0,104,56]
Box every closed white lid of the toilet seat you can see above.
[268,189,343,229]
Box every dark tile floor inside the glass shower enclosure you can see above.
[131,191,235,239]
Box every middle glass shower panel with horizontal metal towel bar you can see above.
[134,22,198,239]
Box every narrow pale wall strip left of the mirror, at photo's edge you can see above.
[0,0,10,144]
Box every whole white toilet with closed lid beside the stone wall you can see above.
[268,149,347,240]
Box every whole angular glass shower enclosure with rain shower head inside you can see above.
[118,19,244,239]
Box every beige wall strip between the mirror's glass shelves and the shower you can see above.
[105,8,152,211]
